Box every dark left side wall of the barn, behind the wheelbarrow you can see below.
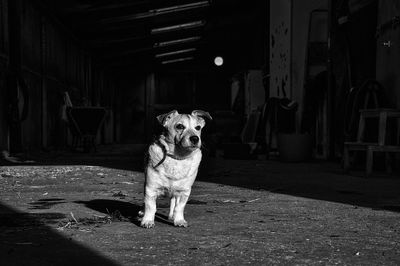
[7,0,114,150]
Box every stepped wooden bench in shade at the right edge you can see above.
[343,108,400,177]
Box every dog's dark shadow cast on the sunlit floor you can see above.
[75,199,173,227]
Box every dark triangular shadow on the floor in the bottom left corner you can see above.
[0,204,118,266]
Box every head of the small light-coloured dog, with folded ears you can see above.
[157,110,212,151]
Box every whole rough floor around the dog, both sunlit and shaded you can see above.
[0,147,400,265]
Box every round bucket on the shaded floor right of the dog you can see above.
[278,134,312,162]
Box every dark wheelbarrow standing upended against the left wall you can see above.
[67,107,106,152]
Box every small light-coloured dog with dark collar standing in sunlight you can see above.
[141,110,212,228]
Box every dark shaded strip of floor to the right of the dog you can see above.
[198,159,400,212]
